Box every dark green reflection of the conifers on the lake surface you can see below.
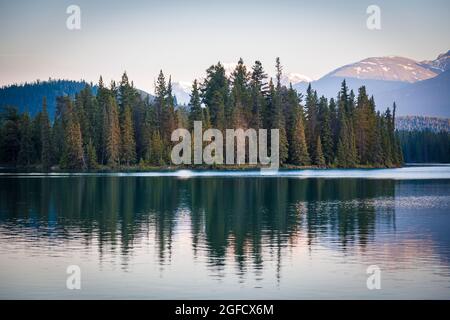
[0,177,396,272]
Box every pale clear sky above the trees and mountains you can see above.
[0,0,450,92]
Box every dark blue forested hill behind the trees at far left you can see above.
[0,80,97,118]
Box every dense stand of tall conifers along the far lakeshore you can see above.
[0,59,403,171]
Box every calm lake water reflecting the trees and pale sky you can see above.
[0,166,450,299]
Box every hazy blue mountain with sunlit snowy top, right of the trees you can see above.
[294,51,450,117]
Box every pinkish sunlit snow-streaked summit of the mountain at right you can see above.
[325,56,438,83]
